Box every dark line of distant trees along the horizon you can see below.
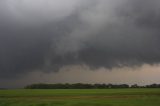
[25,83,160,89]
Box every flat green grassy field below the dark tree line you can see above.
[0,88,160,106]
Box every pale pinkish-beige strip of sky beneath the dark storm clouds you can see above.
[0,64,160,88]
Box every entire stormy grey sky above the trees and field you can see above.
[0,0,160,88]
